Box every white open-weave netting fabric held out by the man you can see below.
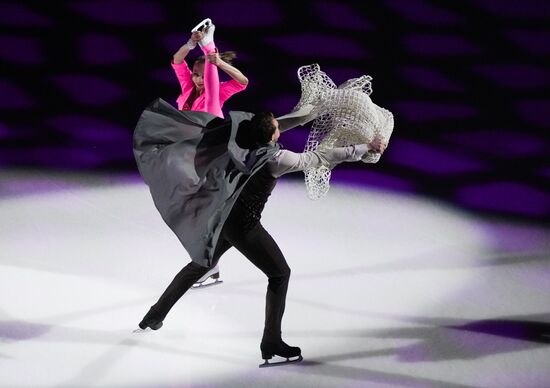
[293,64,393,199]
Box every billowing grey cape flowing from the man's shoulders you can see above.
[134,99,279,267]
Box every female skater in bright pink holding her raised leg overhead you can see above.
[172,19,248,288]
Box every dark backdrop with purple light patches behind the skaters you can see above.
[0,0,550,223]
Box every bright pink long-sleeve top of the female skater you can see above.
[172,61,246,112]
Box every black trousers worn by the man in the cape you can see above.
[150,213,290,342]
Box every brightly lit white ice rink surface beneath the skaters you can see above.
[0,171,550,388]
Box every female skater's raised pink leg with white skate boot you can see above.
[200,24,223,118]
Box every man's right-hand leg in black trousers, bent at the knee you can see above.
[224,223,290,342]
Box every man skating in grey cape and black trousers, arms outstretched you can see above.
[134,100,385,366]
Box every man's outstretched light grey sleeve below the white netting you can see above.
[268,144,369,178]
